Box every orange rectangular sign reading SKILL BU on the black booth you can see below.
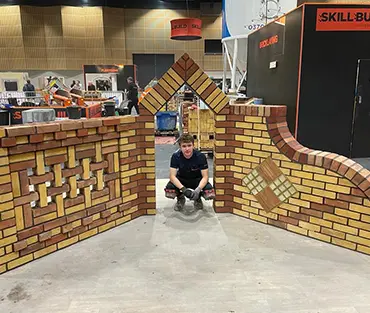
[316,8,370,31]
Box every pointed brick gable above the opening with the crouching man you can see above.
[141,53,229,115]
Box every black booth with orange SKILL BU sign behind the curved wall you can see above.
[247,4,370,158]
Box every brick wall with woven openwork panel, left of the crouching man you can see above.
[0,108,155,273]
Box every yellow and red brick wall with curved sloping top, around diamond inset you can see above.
[214,105,370,254]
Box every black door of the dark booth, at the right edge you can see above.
[351,59,370,158]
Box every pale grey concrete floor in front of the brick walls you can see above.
[0,143,370,313]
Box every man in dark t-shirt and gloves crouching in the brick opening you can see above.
[165,134,215,211]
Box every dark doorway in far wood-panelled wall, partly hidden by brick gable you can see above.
[133,53,175,89]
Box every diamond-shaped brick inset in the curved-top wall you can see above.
[243,158,297,212]
